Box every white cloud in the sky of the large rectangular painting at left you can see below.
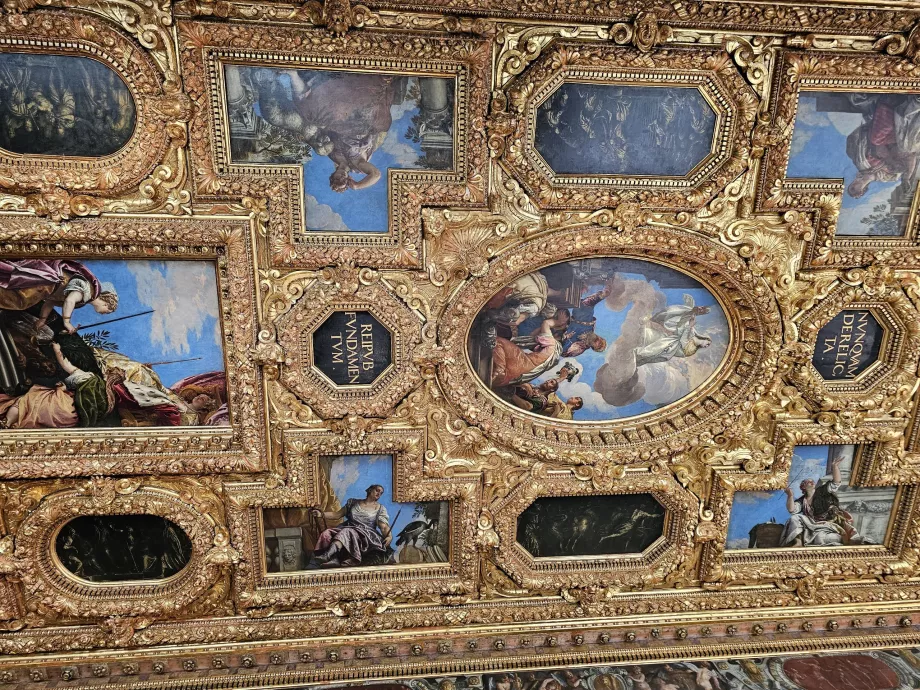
[127,261,221,355]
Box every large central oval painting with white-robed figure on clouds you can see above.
[468,258,729,422]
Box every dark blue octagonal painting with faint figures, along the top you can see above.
[535,82,716,176]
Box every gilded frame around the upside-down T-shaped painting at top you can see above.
[178,21,490,268]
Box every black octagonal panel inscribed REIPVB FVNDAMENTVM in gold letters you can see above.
[313,311,393,386]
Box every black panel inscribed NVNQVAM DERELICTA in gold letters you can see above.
[812,309,884,381]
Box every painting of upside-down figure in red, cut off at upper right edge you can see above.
[786,91,920,237]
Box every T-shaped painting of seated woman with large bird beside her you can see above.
[262,455,450,573]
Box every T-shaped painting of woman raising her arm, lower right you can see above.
[726,445,897,549]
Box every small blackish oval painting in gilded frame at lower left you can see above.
[55,515,192,582]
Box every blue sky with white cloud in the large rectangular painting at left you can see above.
[79,260,224,386]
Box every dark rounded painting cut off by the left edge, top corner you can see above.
[0,53,136,157]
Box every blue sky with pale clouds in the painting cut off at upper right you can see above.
[786,91,903,235]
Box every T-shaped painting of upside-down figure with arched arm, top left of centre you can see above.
[224,65,455,233]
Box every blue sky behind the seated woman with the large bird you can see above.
[322,455,442,548]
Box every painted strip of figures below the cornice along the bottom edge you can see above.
[320,649,920,690]
